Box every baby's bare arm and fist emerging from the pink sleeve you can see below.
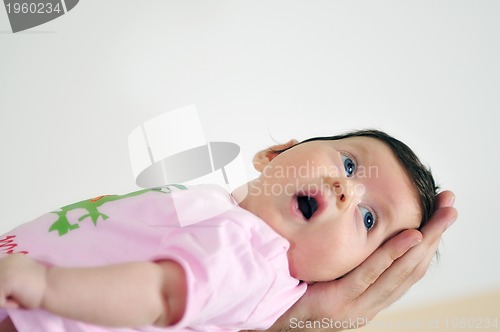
[0,255,186,327]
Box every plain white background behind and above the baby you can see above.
[0,0,500,310]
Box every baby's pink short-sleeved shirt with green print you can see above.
[0,185,307,332]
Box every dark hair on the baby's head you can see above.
[276,129,438,229]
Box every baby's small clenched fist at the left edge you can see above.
[0,254,47,309]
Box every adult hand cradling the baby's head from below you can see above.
[262,191,457,331]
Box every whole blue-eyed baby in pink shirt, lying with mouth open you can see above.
[0,130,436,331]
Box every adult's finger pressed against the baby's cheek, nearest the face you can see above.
[341,229,422,300]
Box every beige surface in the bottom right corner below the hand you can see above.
[361,289,500,332]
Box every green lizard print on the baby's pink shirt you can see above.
[49,184,187,236]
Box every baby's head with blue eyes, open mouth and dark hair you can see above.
[235,130,437,282]
